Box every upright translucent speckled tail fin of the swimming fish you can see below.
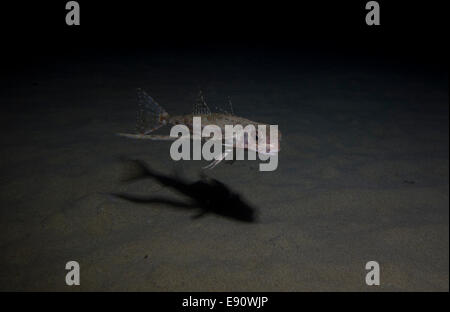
[136,88,169,134]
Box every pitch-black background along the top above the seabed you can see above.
[1,0,448,70]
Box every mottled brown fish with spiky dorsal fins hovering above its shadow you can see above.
[118,89,281,169]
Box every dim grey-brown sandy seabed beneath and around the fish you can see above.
[0,57,449,291]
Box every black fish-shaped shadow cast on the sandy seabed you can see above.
[111,159,257,223]
